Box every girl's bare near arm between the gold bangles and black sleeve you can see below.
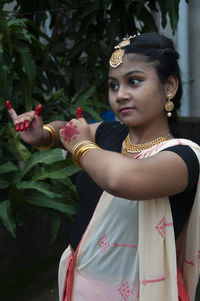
[81,144,189,200]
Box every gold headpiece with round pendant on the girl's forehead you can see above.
[109,34,139,68]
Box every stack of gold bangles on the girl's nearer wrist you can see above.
[72,140,100,168]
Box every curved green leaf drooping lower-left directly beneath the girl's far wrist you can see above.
[19,148,63,180]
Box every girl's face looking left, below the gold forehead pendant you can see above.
[108,54,167,126]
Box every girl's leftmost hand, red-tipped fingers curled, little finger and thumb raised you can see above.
[6,100,44,145]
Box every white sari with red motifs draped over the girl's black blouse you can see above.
[59,139,200,301]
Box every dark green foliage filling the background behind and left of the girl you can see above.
[0,0,185,240]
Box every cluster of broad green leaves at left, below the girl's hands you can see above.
[0,124,78,239]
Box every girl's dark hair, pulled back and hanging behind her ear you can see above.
[124,32,182,137]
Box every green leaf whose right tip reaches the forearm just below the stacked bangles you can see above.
[33,160,80,180]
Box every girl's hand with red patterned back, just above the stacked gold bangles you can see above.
[60,108,93,152]
